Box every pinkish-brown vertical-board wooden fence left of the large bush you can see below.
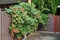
[0,9,12,40]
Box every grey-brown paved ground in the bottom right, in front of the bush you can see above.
[26,32,60,40]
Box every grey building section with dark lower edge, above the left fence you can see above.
[0,0,28,10]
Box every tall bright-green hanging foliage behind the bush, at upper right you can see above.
[32,0,57,15]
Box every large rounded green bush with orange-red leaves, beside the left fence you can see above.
[5,3,41,39]
